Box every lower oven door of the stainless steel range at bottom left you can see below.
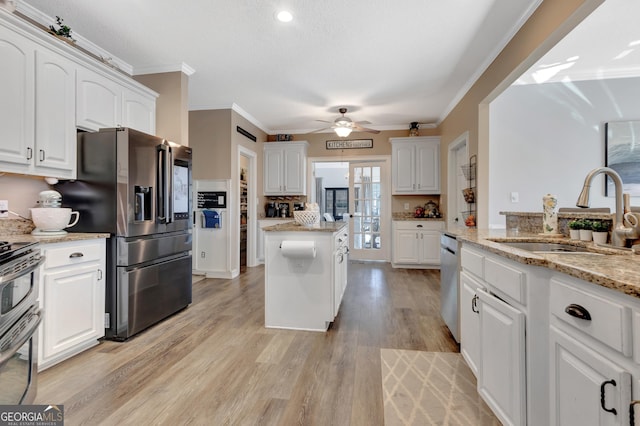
[0,306,42,405]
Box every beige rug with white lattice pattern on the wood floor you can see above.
[380,349,500,426]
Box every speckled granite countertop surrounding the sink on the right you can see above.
[443,227,640,298]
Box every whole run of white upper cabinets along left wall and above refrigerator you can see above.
[0,14,157,179]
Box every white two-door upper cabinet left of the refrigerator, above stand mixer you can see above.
[0,26,76,179]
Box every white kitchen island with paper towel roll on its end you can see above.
[263,222,348,331]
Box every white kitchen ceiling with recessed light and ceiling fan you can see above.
[22,0,640,134]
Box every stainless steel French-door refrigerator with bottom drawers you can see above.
[56,128,192,340]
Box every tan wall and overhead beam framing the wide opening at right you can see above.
[438,0,604,227]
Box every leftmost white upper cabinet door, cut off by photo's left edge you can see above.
[0,27,35,167]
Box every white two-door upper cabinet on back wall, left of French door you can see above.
[263,141,309,196]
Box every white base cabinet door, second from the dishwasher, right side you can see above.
[478,289,528,425]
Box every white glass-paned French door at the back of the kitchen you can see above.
[349,162,390,260]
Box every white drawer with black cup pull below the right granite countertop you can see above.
[549,278,631,356]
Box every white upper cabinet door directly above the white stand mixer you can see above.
[35,48,77,178]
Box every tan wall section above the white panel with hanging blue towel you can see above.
[189,109,232,179]
